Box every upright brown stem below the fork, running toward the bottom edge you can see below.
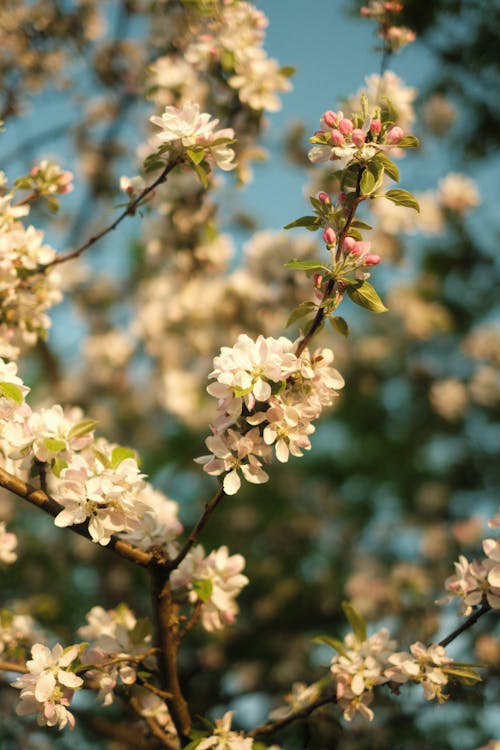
[151,567,192,740]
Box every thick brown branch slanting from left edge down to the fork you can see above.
[0,468,153,568]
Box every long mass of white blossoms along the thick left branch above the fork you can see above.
[0,360,182,554]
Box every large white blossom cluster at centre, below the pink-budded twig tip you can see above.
[197,334,344,495]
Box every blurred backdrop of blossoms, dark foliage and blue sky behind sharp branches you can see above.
[0,0,500,750]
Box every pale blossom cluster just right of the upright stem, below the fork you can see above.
[171,545,248,632]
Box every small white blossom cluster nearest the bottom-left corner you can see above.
[12,643,83,729]
